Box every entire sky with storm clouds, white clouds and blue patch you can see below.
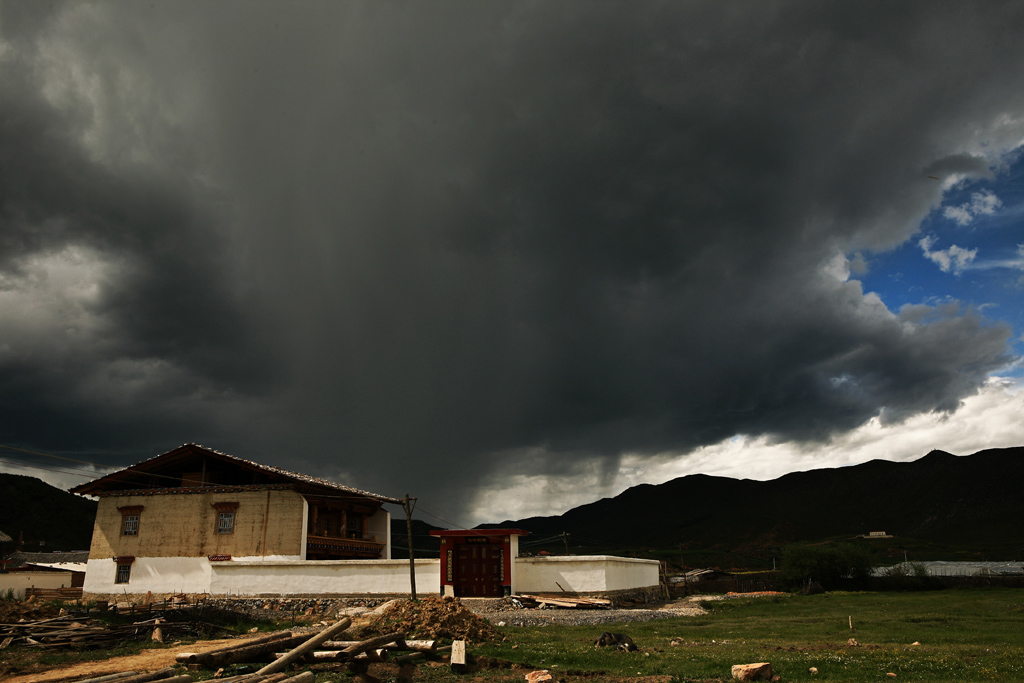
[0,0,1024,525]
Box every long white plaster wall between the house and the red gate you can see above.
[210,559,440,596]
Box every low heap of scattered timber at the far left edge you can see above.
[0,615,178,649]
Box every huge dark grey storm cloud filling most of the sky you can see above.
[3,2,1024,509]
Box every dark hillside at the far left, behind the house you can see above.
[0,474,96,552]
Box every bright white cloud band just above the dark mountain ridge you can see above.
[469,378,1024,524]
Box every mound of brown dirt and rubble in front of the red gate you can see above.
[361,595,502,642]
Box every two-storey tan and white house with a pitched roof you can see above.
[72,443,397,595]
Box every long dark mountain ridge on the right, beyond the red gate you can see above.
[483,447,1024,559]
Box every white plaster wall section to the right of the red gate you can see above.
[512,555,659,593]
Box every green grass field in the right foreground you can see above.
[460,589,1024,682]
